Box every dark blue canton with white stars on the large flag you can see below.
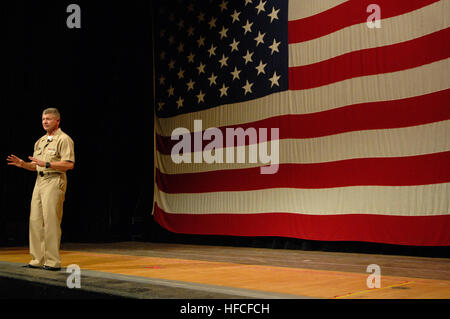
[154,0,289,117]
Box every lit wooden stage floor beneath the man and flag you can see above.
[0,242,450,299]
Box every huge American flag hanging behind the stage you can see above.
[153,0,450,246]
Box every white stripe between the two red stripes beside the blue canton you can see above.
[289,1,450,67]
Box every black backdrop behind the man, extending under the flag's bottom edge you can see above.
[0,0,450,257]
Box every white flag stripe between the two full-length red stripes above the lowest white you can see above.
[156,120,450,174]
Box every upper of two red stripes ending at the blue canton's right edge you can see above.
[288,0,439,43]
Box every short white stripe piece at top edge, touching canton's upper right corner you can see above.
[288,0,347,21]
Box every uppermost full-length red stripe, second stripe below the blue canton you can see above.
[156,89,450,155]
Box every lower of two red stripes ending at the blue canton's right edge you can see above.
[289,28,450,90]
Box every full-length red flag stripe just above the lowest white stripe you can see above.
[156,151,450,193]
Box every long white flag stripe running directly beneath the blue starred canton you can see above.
[155,59,450,136]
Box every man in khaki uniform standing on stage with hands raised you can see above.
[7,108,75,270]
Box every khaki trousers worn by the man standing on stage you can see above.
[29,173,67,268]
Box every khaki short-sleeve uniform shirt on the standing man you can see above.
[33,128,75,172]
